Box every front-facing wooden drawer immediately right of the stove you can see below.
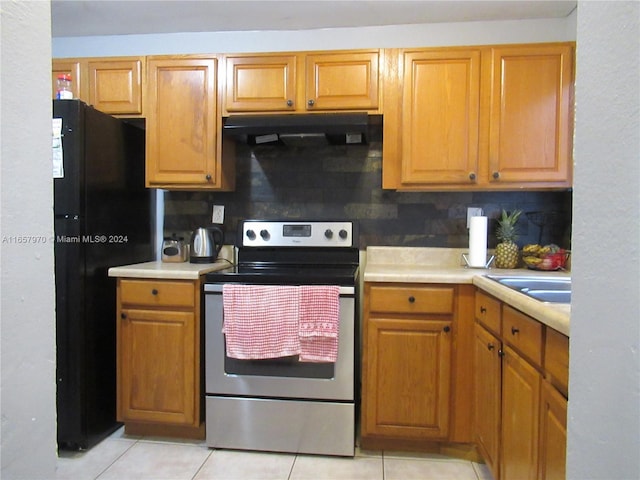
[369,286,454,314]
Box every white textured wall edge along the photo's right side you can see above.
[567,1,640,480]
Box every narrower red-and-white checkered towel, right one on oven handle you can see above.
[300,285,340,362]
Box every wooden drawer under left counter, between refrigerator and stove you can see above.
[120,280,195,307]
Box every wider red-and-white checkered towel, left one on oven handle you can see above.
[222,284,300,360]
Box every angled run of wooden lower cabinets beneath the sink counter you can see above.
[473,291,569,480]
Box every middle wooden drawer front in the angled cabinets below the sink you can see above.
[502,305,543,367]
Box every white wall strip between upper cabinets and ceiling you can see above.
[53,15,576,58]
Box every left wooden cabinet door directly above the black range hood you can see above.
[224,55,296,112]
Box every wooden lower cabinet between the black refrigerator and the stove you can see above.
[117,279,204,438]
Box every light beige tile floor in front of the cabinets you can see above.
[56,429,492,480]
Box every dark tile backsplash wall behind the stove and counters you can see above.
[164,127,572,249]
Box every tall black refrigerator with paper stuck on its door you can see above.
[53,100,155,450]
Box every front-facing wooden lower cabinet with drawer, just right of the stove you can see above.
[361,283,476,458]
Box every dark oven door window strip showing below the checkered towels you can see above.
[224,355,334,380]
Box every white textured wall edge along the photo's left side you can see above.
[0,1,56,480]
